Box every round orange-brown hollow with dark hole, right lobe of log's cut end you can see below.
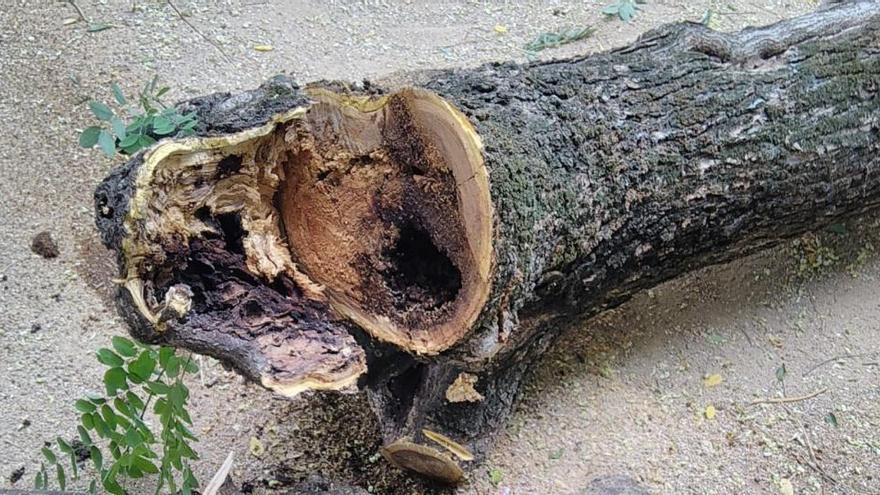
[288,90,492,354]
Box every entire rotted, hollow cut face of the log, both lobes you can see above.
[111,88,492,396]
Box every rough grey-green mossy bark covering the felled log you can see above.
[96,2,880,484]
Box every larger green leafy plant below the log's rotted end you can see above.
[34,336,198,495]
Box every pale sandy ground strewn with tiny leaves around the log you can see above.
[0,0,880,494]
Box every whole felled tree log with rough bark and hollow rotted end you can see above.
[95,1,880,481]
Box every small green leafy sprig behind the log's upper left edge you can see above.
[79,77,198,158]
